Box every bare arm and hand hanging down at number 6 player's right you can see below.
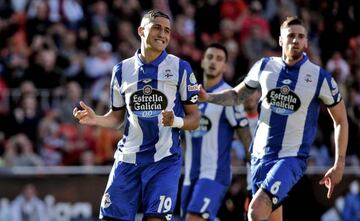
[320,100,348,198]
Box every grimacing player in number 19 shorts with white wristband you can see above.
[74,10,199,221]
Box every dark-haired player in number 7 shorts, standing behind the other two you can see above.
[181,43,251,221]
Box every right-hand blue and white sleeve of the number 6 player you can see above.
[319,70,342,107]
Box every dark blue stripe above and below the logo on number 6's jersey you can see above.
[266,65,300,157]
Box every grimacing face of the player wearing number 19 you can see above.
[139,17,171,52]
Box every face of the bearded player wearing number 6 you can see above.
[279,25,308,61]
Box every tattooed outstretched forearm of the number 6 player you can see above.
[208,86,255,106]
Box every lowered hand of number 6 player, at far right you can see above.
[319,165,344,199]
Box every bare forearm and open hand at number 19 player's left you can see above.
[73,101,125,129]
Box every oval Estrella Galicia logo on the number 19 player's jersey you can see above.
[130,85,167,118]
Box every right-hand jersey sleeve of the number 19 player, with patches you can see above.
[179,60,199,104]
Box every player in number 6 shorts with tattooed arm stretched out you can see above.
[199,17,348,221]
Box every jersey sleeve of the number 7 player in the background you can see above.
[225,105,249,128]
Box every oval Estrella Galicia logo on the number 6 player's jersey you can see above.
[266,85,301,115]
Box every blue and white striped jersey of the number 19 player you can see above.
[110,50,198,164]
